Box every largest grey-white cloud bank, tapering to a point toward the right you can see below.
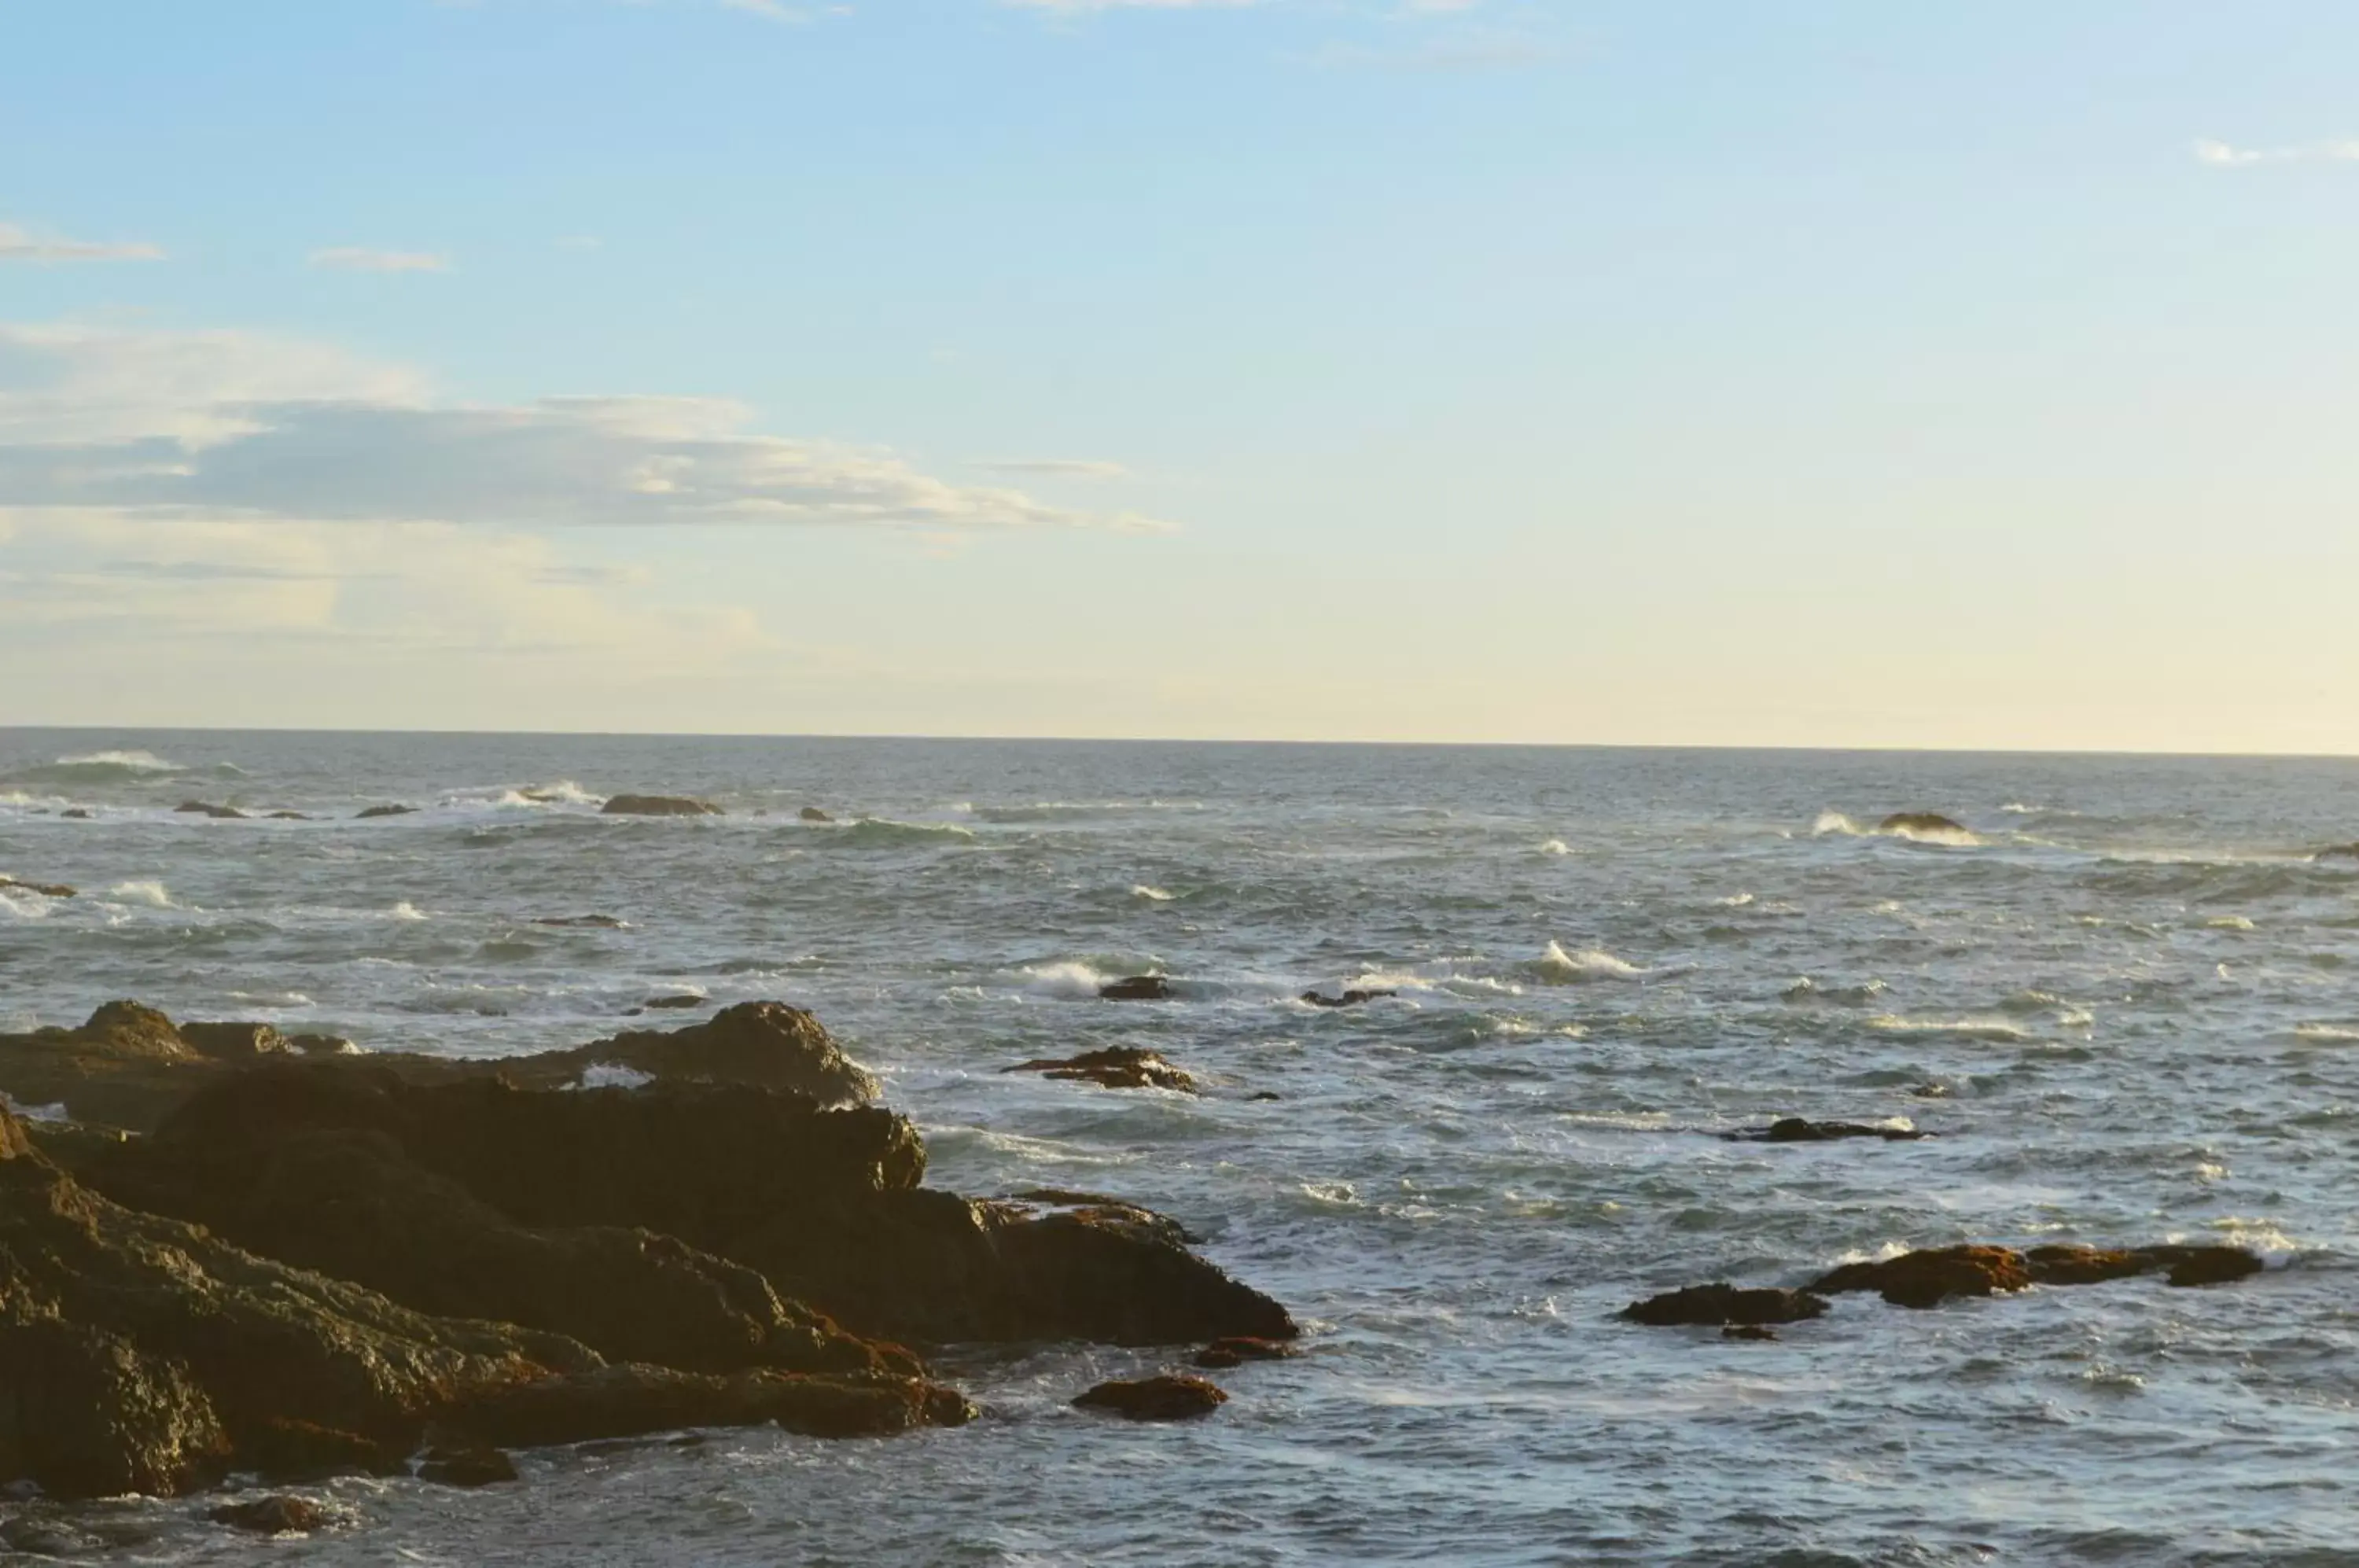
[0,326,1163,533]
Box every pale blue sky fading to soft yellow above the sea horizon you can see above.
[0,0,2359,753]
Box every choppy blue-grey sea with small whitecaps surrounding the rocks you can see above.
[0,731,2359,1563]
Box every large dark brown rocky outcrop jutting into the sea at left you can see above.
[0,1002,1297,1500]
